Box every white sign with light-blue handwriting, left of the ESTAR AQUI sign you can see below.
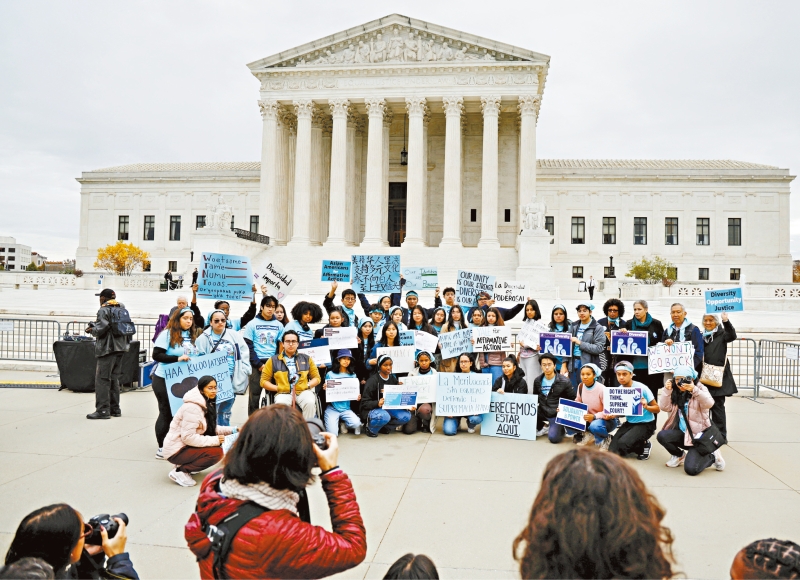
[436,373,492,417]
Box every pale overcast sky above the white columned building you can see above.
[0,0,800,259]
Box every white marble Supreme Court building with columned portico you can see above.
[77,14,794,284]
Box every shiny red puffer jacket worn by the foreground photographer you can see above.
[185,469,367,579]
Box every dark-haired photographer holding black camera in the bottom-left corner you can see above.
[5,503,139,580]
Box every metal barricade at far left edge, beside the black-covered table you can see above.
[0,318,61,361]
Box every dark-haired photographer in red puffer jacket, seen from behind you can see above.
[185,405,367,578]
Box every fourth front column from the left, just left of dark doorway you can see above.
[361,99,387,246]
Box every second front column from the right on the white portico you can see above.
[478,96,500,248]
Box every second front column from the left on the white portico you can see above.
[289,100,314,246]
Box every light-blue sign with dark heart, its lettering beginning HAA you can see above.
[160,352,235,415]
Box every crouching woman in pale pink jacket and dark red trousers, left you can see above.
[164,375,236,487]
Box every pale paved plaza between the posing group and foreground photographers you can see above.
[0,371,800,579]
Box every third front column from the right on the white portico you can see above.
[439,97,464,248]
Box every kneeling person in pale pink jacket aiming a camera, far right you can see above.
[657,365,725,475]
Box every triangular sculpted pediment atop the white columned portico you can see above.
[247,14,550,73]
